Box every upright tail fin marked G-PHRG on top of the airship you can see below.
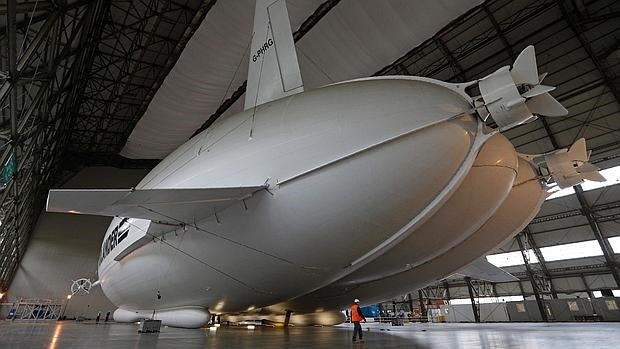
[245,0,304,110]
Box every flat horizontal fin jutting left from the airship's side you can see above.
[47,185,265,224]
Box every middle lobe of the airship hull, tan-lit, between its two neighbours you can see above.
[344,134,517,283]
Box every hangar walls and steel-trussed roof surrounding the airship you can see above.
[0,0,620,346]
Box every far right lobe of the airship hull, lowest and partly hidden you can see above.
[280,157,548,311]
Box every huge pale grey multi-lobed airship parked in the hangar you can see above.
[47,0,604,328]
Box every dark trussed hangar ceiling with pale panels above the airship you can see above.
[0,0,620,297]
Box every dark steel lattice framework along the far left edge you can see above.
[0,1,103,289]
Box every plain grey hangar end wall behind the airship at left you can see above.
[0,167,148,318]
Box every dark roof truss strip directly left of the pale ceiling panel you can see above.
[68,0,215,160]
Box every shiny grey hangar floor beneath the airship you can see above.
[0,321,620,349]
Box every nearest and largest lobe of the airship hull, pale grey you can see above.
[99,77,485,318]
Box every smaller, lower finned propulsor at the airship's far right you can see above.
[545,138,606,189]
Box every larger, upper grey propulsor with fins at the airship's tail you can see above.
[478,45,568,131]
